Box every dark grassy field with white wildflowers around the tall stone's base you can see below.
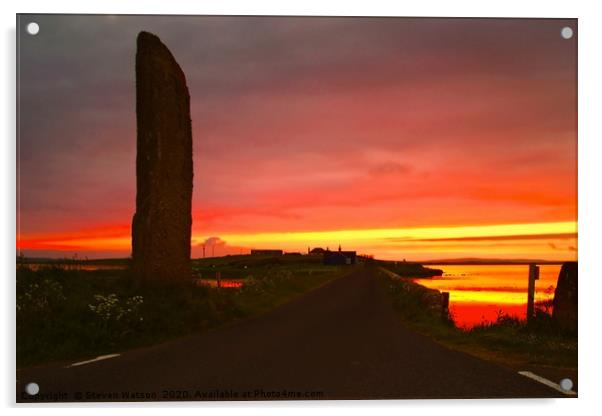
[17,256,352,368]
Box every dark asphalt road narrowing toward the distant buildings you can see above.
[17,268,563,402]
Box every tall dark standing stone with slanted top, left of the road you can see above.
[132,32,193,281]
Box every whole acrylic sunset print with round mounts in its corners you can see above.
[16,14,578,402]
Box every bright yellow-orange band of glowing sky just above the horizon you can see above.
[17,221,577,259]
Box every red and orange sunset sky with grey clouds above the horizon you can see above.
[17,15,577,260]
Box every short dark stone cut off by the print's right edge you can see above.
[552,261,578,332]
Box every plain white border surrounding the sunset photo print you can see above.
[0,0,602,416]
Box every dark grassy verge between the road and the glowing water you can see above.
[378,270,577,380]
